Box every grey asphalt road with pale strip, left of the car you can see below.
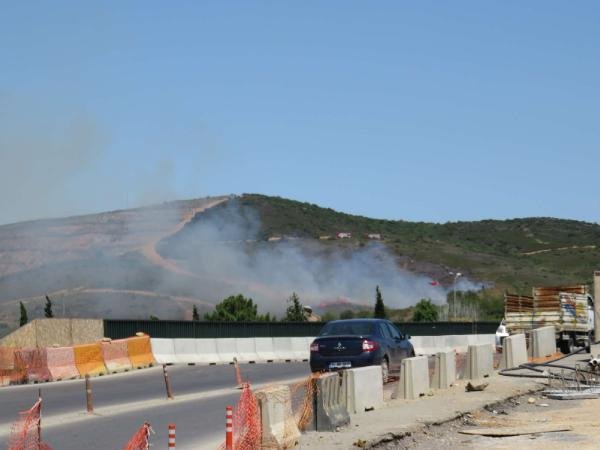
[0,362,310,450]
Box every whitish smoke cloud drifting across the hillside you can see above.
[159,201,474,314]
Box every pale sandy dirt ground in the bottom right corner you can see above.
[375,395,600,450]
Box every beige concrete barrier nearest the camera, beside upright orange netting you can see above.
[255,386,300,449]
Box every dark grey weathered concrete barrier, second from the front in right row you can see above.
[313,373,350,431]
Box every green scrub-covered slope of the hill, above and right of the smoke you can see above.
[239,194,600,292]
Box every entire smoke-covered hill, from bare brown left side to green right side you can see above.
[0,194,600,335]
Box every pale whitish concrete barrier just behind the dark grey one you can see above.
[342,366,383,414]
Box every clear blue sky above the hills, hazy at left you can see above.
[0,1,600,223]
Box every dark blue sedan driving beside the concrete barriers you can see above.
[310,319,415,383]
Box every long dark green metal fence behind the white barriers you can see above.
[104,320,498,339]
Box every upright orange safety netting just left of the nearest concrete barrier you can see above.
[220,383,262,450]
